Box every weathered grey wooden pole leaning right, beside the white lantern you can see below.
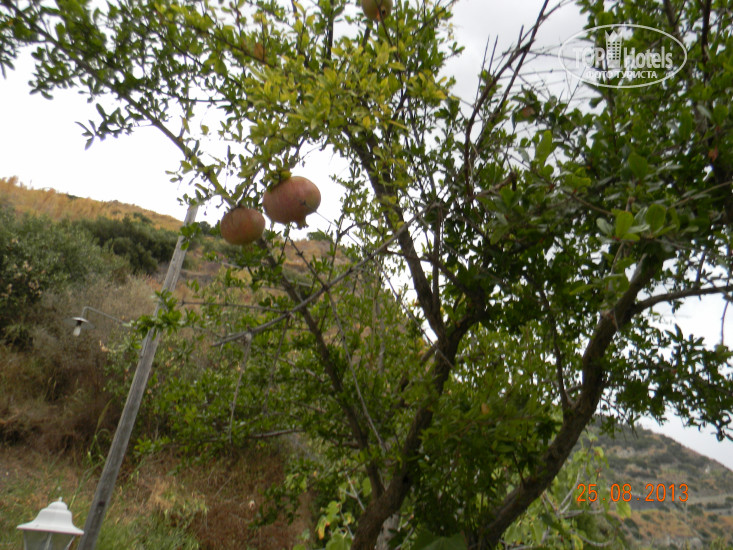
[77,204,198,550]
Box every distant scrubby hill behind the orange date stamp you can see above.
[594,427,733,550]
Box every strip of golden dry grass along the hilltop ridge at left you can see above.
[0,177,182,231]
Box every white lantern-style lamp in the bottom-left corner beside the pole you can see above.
[18,499,84,550]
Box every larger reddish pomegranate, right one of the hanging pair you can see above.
[262,176,321,227]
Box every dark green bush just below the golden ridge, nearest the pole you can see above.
[76,213,178,274]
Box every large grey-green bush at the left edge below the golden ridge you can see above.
[0,208,119,345]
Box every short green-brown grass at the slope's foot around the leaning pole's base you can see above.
[0,445,309,550]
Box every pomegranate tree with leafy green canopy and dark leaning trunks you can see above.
[0,0,733,549]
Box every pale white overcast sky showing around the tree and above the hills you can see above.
[0,0,733,474]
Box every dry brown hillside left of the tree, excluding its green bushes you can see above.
[0,180,311,550]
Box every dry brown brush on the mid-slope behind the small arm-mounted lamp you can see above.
[0,278,154,460]
